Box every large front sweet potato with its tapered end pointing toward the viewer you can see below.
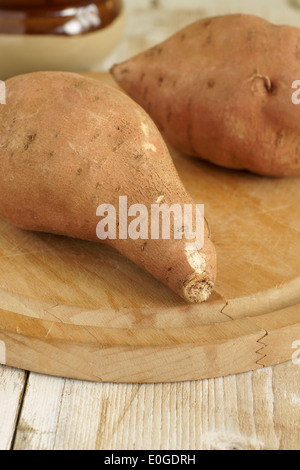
[0,72,216,302]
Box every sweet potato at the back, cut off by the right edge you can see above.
[111,15,300,177]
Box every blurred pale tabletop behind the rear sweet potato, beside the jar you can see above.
[109,0,300,67]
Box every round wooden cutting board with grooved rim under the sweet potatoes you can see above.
[0,74,300,383]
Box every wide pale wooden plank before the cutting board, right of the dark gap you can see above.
[11,362,300,450]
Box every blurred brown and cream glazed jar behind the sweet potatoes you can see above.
[0,0,125,80]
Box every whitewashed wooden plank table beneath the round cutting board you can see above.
[0,0,300,450]
